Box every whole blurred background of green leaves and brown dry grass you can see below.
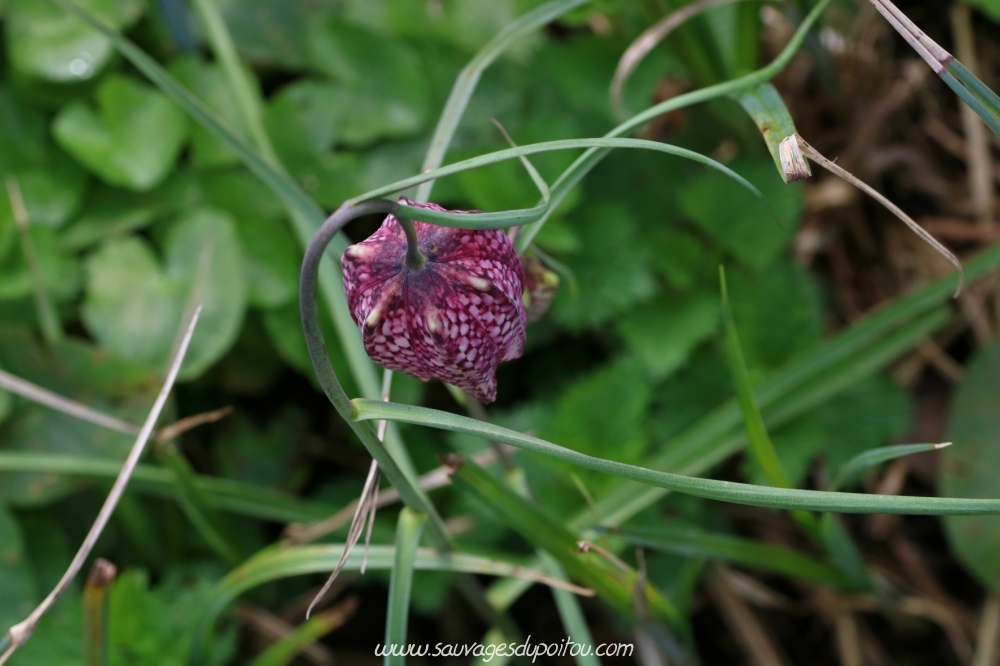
[0,0,1000,666]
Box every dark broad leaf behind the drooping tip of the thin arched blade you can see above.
[677,159,802,270]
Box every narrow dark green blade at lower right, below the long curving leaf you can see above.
[599,524,851,588]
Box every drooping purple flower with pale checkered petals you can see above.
[340,200,526,403]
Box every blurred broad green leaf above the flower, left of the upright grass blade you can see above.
[307,20,430,145]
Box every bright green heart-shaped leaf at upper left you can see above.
[52,75,188,191]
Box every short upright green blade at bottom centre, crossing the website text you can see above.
[383,507,427,666]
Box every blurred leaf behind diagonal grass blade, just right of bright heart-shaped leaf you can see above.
[170,55,250,166]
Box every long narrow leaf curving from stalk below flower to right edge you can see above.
[352,399,1000,515]
